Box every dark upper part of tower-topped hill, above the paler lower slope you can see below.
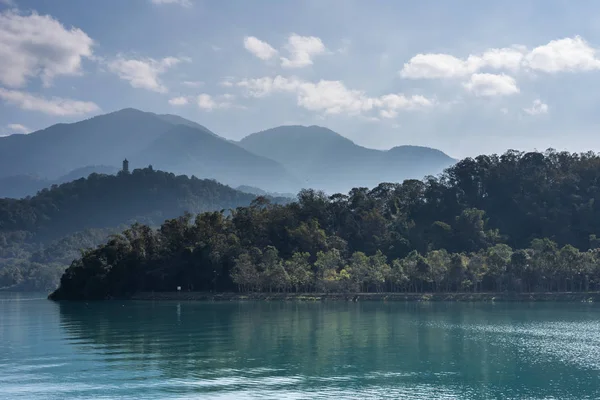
[0,168,274,239]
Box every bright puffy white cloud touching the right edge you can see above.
[524,36,600,73]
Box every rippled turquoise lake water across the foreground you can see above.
[0,294,600,400]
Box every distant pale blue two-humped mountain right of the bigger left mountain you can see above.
[239,126,456,193]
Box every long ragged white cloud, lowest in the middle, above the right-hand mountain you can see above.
[237,76,435,118]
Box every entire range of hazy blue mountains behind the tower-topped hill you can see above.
[0,108,455,197]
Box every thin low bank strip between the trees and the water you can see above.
[129,292,600,303]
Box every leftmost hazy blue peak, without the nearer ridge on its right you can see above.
[0,108,173,179]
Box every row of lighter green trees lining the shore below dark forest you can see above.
[231,239,600,293]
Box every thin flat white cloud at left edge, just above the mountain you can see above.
[0,88,100,116]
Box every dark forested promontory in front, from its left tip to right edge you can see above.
[51,150,600,299]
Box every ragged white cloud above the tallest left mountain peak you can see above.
[108,56,184,93]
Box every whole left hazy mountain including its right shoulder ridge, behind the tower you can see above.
[0,108,299,194]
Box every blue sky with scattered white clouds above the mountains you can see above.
[0,0,600,158]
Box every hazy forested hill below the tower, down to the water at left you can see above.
[0,167,289,290]
